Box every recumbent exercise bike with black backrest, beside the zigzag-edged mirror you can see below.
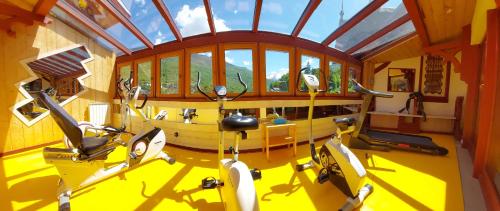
[38,75,175,210]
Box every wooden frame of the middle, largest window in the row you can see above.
[218,43,260,97]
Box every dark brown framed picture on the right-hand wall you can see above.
[420,55,451,103]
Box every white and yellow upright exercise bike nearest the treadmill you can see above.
[296,67,373,210]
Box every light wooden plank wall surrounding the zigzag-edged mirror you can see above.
[0,18,115,154]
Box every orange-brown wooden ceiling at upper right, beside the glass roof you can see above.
[364,0,476,63]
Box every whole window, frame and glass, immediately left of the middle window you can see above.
[186,46,216,96]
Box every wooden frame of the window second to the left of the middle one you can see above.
[155,49,185,98]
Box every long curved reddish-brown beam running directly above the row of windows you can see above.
[116,31,363,66]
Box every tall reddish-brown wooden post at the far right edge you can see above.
[473,9,500,210]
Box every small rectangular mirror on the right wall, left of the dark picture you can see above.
[387,68,415,92]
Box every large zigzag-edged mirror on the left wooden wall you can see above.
[12,45,92,126]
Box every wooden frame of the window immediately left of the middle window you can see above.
[184,45,219,98]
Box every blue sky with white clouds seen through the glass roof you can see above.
[69,0,401,56]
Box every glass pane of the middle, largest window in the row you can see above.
[225,49,254,93]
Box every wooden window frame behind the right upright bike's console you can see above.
[294,48,326,96]
